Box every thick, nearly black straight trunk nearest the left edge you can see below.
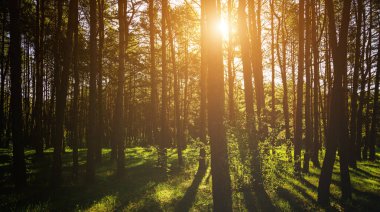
[9,0,26,188]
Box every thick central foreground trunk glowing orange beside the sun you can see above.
[205,0,232,211]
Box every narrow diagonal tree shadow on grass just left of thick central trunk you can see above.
[175,167,207,212]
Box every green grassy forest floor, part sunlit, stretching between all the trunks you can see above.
[0,142,380,211]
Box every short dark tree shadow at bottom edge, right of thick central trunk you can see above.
[243,188,278,211]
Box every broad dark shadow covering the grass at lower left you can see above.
[0,148,172,211]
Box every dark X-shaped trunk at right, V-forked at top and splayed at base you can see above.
[318,0,351,205]
